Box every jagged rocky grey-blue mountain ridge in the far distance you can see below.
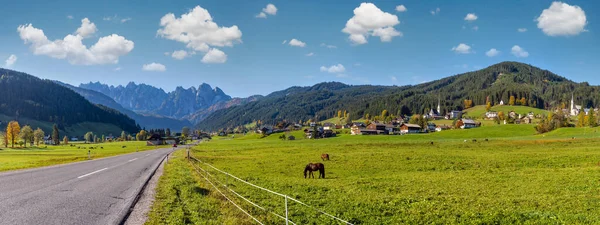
[79,82,231,119]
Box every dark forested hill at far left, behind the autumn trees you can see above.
[0,68,139,133]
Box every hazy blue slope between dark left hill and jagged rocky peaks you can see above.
[55,81,192,131]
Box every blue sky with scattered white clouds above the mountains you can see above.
[0,0,600,97]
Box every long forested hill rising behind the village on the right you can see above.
[198,62,600,130]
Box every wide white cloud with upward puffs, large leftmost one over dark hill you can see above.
[17,18,134,65]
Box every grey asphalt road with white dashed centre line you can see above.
[0,145,173,225]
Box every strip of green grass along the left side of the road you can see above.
[0,141,156,171]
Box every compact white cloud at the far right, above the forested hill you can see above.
[536,2,587,36]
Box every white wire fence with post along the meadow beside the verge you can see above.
[187,150,353,225]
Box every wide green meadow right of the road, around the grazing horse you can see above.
[150,125,600,224]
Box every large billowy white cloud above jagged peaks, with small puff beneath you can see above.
[157,6,242,63]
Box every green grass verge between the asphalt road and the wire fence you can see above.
[146,150,251,225]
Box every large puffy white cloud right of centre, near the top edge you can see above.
[342,3,402,45]
